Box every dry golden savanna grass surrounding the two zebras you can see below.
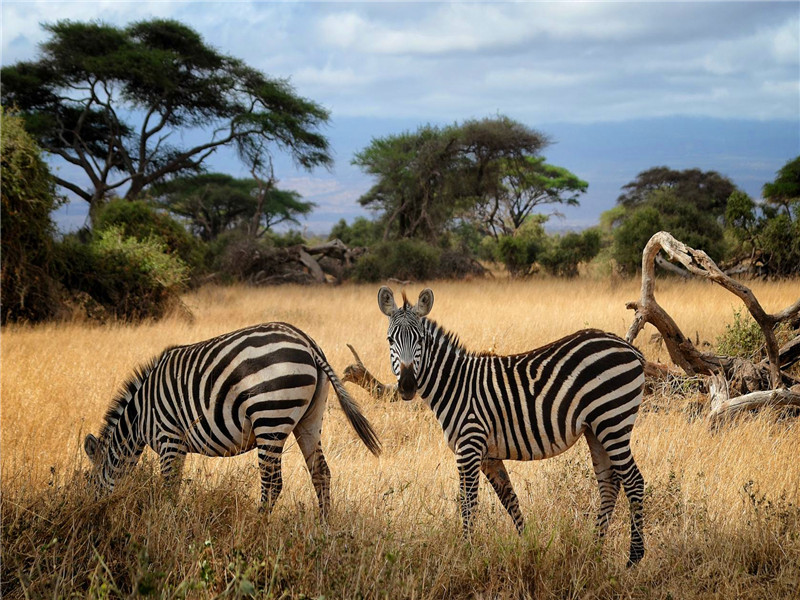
[0,280,800,599]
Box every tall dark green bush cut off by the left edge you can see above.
[0,110,60,323]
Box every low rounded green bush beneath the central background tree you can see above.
[353,239,442,283]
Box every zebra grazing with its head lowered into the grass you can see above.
[84,323,380,517]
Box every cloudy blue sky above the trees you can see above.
[2,0,800,232]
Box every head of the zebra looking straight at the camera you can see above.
[378,286,433,400]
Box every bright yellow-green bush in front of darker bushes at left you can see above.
[58,226,189,321]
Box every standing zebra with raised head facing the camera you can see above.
[378,286,644,565]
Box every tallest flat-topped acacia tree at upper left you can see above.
[2,19,332,223]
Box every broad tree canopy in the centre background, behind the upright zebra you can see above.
[353,116,549,241]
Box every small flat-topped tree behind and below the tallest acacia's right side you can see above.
[153,173,315,241]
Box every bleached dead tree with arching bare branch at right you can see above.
[626,231,800,414]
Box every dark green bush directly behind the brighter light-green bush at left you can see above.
[95,198,203,267]
